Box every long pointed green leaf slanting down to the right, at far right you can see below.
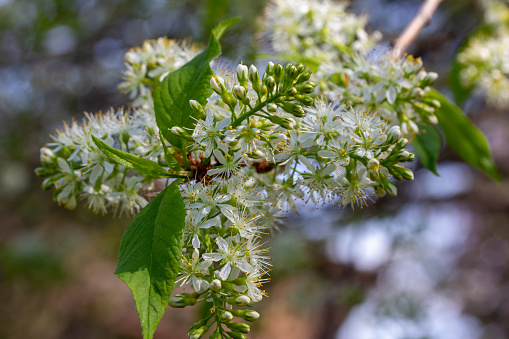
[429,89,500,181]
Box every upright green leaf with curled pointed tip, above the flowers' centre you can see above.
[153,18,240,149]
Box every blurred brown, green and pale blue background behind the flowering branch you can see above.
[0,0,509,339]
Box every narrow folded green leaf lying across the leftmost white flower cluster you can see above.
[92,135,177,178]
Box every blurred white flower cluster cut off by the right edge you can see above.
[458,1,509,108]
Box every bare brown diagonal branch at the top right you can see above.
[393,0,442,57]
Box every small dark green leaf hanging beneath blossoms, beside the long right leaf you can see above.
[412,124,442,176]
